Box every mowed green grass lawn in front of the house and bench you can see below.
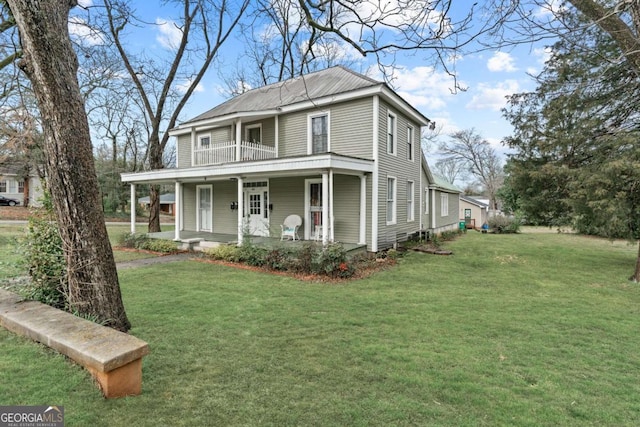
[0,232,640,427]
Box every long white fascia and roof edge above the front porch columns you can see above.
[121,153,373,184]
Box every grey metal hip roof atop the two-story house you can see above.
[184,66,385,123]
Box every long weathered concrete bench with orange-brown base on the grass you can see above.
[0,289,149,398]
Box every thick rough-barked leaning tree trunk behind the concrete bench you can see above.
[7,0,130,331]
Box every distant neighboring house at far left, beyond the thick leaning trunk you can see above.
[0,162,42,206]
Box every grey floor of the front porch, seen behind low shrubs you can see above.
[147,230,367,252]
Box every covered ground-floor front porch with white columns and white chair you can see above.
[122,153,375,249]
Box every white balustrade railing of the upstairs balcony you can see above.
[193,141,276,166]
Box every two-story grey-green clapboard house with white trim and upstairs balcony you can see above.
[122,67,460,252]
